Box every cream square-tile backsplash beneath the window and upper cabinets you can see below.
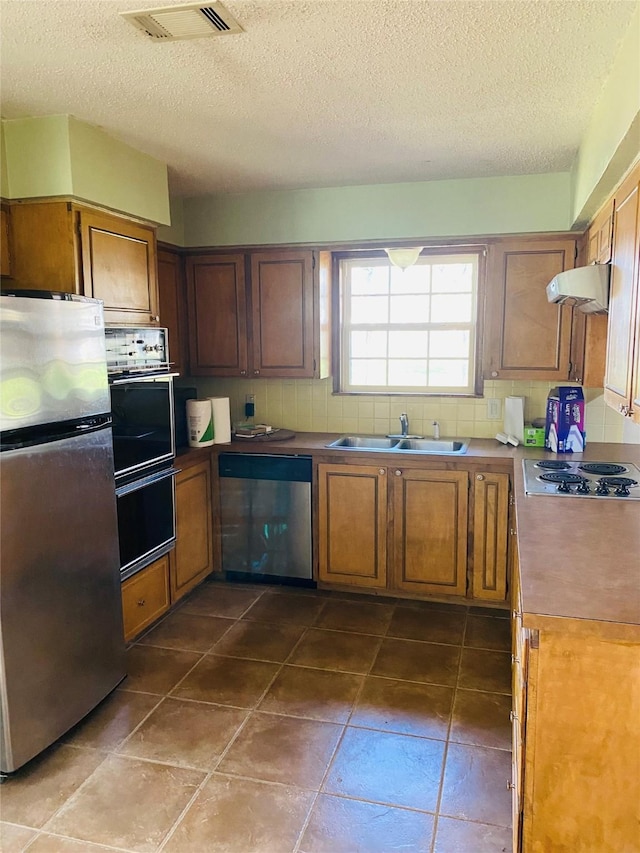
[179,377,640,444]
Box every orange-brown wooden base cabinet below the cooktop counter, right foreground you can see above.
[510,544,640,853]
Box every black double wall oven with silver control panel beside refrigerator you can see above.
[106,326,177,580]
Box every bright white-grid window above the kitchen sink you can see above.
[339,246,482,395]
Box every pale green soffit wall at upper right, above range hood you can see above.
[572,7,640,226]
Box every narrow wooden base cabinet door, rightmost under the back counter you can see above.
[472,473,509,601]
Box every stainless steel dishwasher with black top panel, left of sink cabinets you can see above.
[218,453,315,586]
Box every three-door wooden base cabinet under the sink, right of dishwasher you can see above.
[318,463,510,604]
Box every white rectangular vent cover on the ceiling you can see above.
[120,3,243,41]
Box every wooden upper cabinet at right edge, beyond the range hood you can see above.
[604,166,640,423]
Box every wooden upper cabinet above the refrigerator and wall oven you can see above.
[11,202,159,325]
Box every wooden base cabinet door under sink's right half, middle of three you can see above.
[390,468,469,595]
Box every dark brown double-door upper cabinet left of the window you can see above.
[186,250,330,378]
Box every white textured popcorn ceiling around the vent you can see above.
[0,0,638,196]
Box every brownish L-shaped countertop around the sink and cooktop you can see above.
[176,433,640,638]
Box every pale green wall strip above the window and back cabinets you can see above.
[184,173,571,246]
